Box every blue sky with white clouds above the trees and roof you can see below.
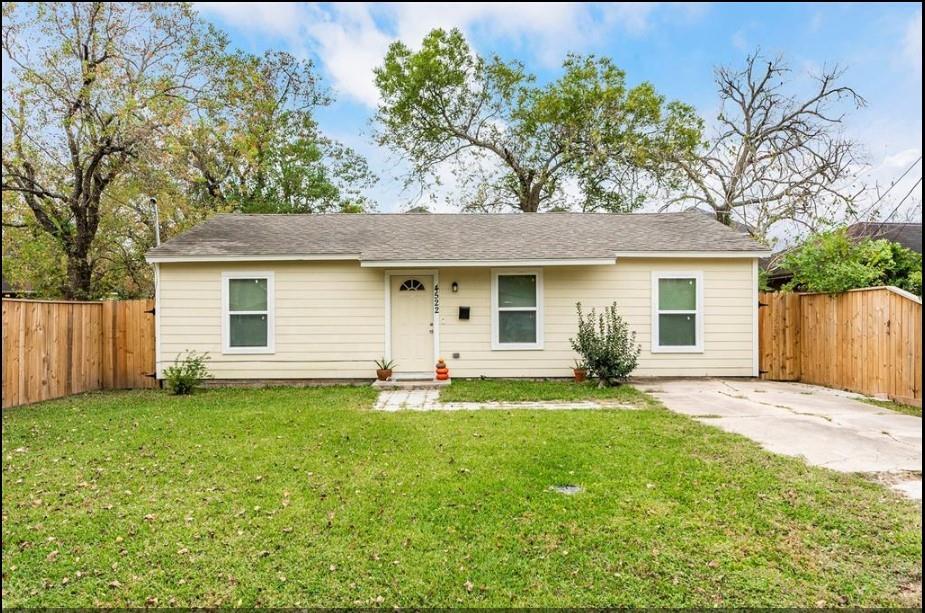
[195,2,922,220]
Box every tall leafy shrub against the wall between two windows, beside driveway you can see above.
[570,302,641,386]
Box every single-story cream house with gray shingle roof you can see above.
[147,212,768,380]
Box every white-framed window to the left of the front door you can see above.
[222,272,274,353]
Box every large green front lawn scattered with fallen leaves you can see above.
[2,383,922,607]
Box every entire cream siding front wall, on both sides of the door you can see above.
[158,258,757,379]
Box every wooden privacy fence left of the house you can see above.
[3,300,157,408]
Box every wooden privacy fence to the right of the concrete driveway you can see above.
[758,287,922,406]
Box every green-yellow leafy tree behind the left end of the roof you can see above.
[177,52,375,213]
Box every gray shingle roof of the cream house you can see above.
[147,212,766,261]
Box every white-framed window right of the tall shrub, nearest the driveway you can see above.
[652,272,703,353]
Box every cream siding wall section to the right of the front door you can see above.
[440,258,757,377]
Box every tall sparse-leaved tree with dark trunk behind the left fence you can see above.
[2,2,224,299]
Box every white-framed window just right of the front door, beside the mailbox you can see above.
[491,270,543,349]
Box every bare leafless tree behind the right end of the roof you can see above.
[671,53,865,238]
